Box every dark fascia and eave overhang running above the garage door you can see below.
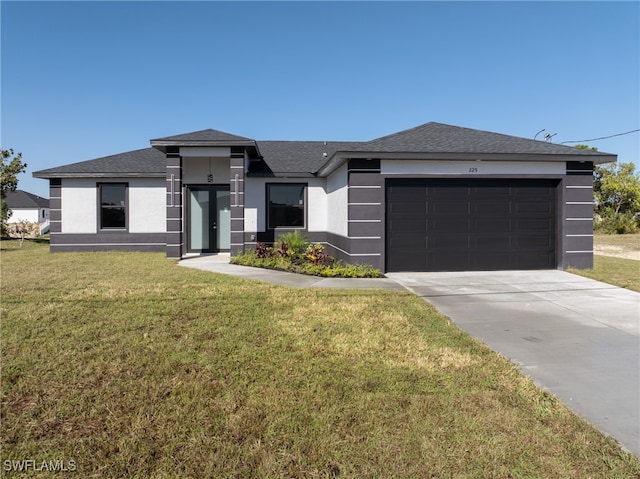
[317,151,618,177]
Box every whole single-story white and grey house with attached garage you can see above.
[34,123,616,271]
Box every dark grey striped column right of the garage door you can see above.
[559,161,593,269]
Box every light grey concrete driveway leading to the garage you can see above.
[387,271,640,455]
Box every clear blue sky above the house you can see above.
[0,0,640,196]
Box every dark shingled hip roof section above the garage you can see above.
[358,122,603,156]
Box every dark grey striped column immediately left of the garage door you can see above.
[347,159,384,270]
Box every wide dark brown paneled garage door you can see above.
[386,179,557,271]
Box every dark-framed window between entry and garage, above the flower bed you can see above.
[267,183,307,229]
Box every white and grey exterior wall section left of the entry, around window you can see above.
[50,178,166,251]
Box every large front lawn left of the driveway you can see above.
[1,242,640,478]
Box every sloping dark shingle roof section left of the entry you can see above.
[33,148,167,178]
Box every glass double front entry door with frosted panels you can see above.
[187,185,231,253]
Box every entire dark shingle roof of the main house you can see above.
[33,122,615,178]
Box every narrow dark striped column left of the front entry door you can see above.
[166,147,185,258]
